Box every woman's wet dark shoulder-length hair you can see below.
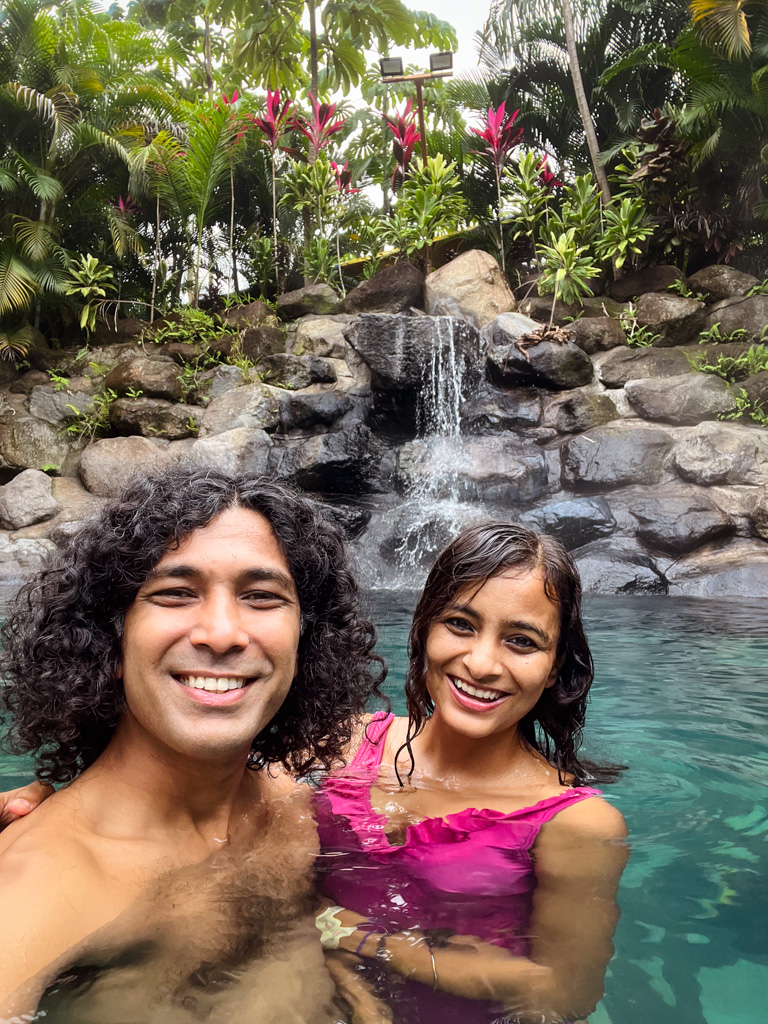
[395,522,621,785]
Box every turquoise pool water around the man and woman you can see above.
[0,594,768,1024]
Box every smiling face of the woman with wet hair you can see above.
[427,569,560,739]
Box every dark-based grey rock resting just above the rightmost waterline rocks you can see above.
[630,495,736,556]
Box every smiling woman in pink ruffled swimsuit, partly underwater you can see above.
[317,523,626,1024]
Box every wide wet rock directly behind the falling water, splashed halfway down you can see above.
[397,437,550,504]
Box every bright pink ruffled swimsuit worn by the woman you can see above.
[316,712,599,1024]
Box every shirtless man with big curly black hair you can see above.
[0,470,381,1024]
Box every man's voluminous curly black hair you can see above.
[2,469,386,782]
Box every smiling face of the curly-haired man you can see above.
[118,508,300,761]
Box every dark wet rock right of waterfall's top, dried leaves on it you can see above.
[486,341,595,390]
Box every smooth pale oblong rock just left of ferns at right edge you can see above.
[625,373,736,425]
